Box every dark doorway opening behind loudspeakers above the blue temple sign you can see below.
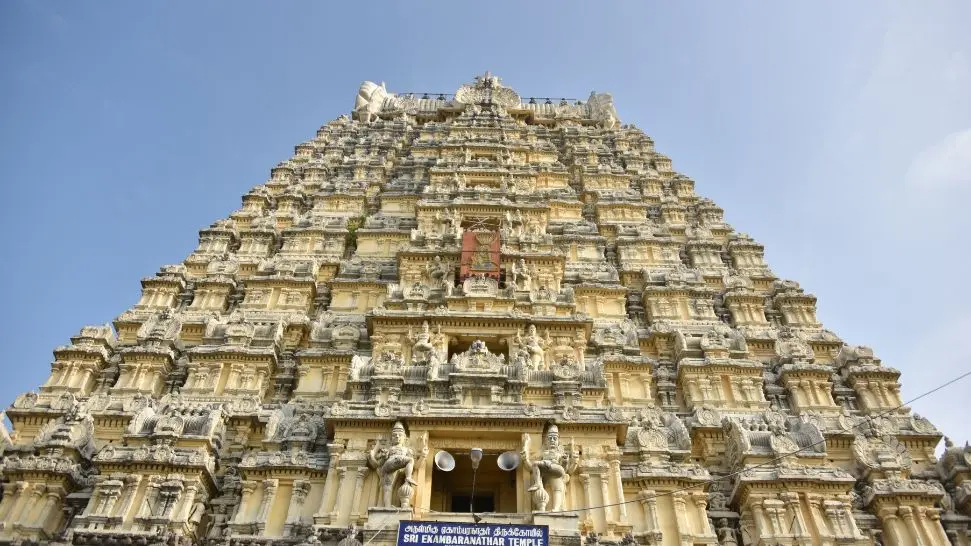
[429,450,517,513]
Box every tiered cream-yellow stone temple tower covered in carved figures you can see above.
[0,74,971,546]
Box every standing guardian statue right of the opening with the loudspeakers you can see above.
[521,424,580,512]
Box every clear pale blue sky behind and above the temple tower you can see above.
[0,0,971,443]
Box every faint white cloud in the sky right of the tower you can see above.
[907,128,971,189]
